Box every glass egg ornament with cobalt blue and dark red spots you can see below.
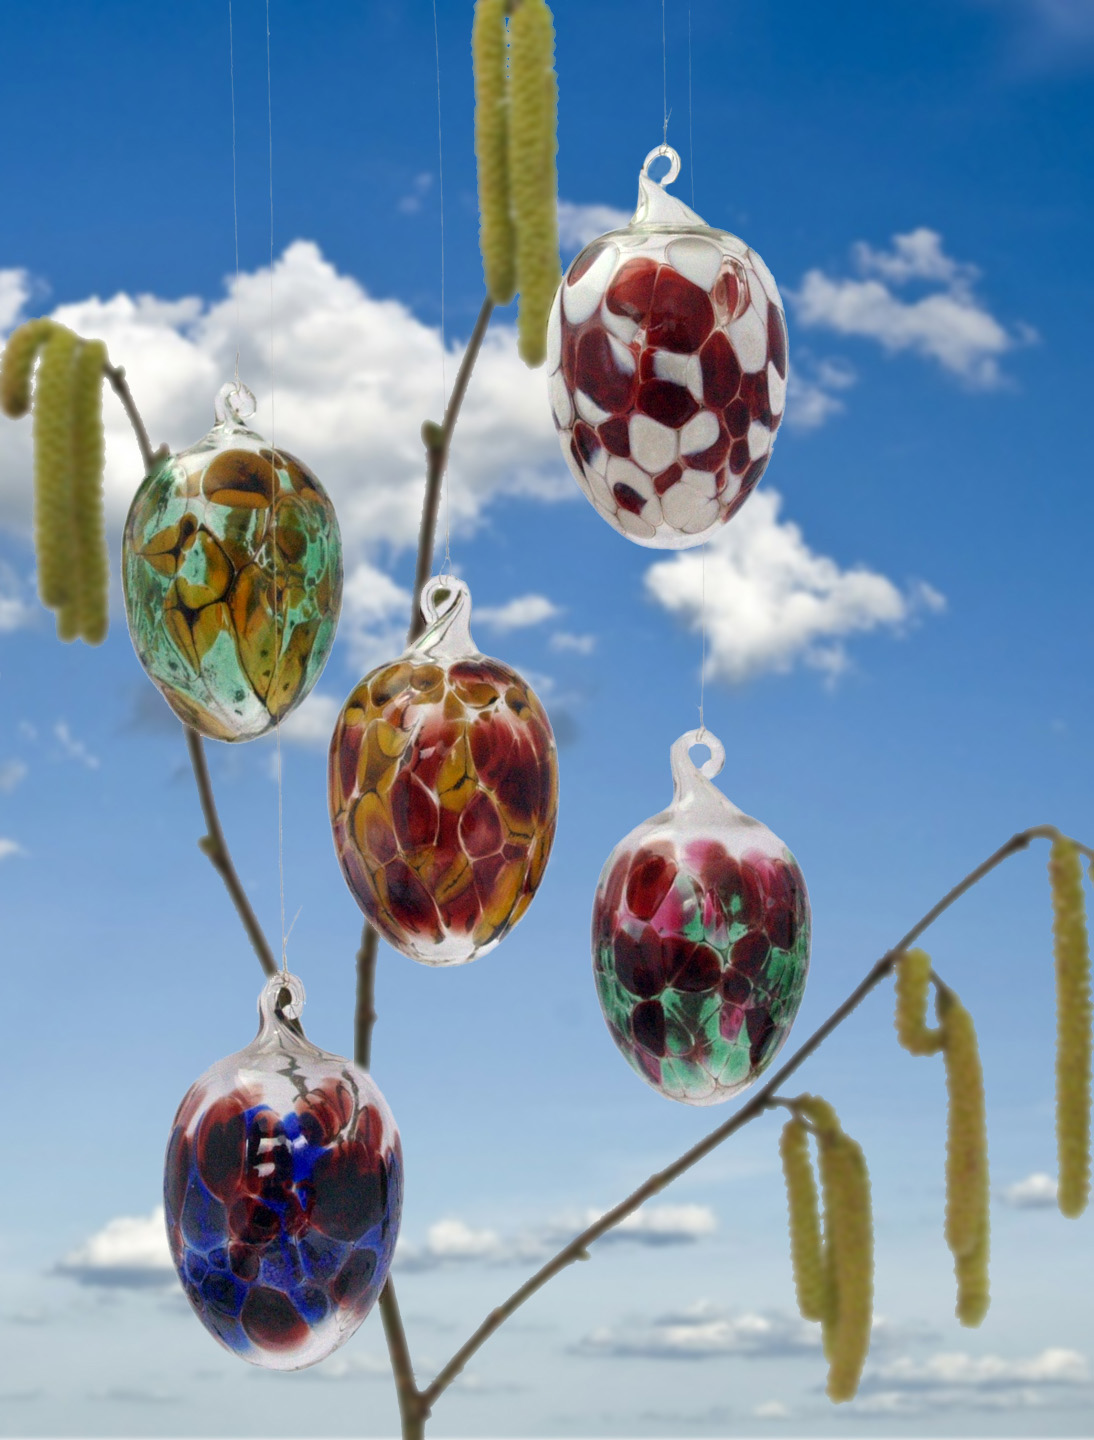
[164,972,403,1369]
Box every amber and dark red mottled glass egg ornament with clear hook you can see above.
[328,576,559,965]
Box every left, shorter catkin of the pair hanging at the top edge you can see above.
[471,0,517,305]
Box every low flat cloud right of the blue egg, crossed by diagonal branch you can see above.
[396,1205,717,1272]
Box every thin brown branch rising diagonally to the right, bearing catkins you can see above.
[422,825,1087,1407]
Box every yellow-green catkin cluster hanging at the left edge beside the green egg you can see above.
[0,326,109,645]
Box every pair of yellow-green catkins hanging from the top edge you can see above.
[471,0,561,366]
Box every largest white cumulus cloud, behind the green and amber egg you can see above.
[0,240,564,584]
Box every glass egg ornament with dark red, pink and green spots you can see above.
[593,730,810,1104]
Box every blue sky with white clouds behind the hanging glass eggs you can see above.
[0,0,1094,1437]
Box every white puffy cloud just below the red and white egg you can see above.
[646,490,944,683]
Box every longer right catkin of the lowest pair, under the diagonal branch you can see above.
[795,1096,874,1404]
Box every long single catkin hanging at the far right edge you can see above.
[1048,838,1091,1220]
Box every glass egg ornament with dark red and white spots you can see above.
[547,145,787,550]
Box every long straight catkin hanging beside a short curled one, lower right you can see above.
[939,991,989,1325]
